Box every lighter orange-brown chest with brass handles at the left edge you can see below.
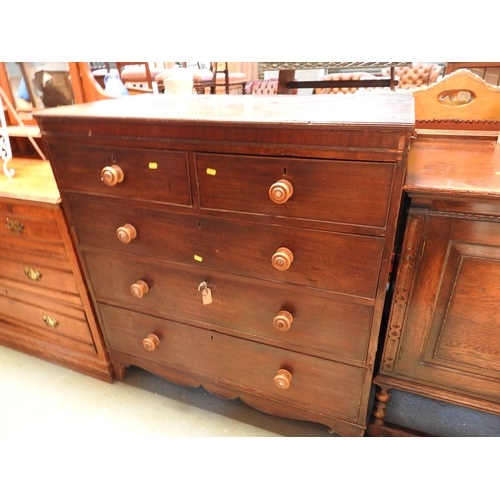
[0,159,114,382]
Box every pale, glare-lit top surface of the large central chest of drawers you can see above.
[37,94,414,127]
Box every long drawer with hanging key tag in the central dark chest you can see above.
[85,252,372,361]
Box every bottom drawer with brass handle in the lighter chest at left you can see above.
[0,287,92,344]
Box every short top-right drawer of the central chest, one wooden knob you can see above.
[196,154,395,228]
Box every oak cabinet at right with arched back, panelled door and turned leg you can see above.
[369,70,500,436]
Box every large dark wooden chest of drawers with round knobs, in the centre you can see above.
[37,94,413,435]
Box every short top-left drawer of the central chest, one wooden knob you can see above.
[51,144,192,206]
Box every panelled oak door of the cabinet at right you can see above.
[394,217,500,402]
